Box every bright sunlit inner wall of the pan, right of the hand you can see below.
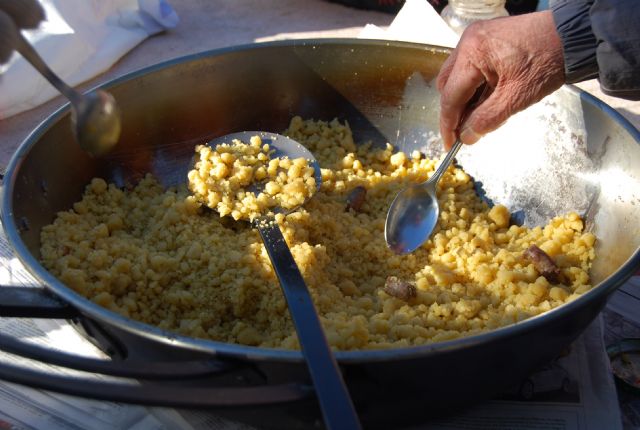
[450,87,640,286]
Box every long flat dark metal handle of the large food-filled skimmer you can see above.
[254,217,361,429]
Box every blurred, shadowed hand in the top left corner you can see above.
[0,0,44,64]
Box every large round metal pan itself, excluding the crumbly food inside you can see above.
[0,39,640,424]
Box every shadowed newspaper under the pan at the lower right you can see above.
[421,317,622,430]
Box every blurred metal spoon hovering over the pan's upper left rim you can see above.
[8,20,121,157]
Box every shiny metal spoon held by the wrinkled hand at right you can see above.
[384,139,462,254]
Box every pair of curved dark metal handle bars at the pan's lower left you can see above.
[0,333,313,407]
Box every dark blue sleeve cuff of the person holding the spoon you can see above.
[550,0,640,100]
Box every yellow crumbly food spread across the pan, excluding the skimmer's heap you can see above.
[41,117,596,350]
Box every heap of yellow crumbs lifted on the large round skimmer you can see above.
[188,136,316,220]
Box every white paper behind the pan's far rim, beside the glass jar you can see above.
[359,0,460,48]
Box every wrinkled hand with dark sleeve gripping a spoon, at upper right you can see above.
[437,11,565,150]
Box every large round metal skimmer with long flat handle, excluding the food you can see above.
[208,131,360,429]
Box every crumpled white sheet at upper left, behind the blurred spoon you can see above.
[0,0,179,118]
